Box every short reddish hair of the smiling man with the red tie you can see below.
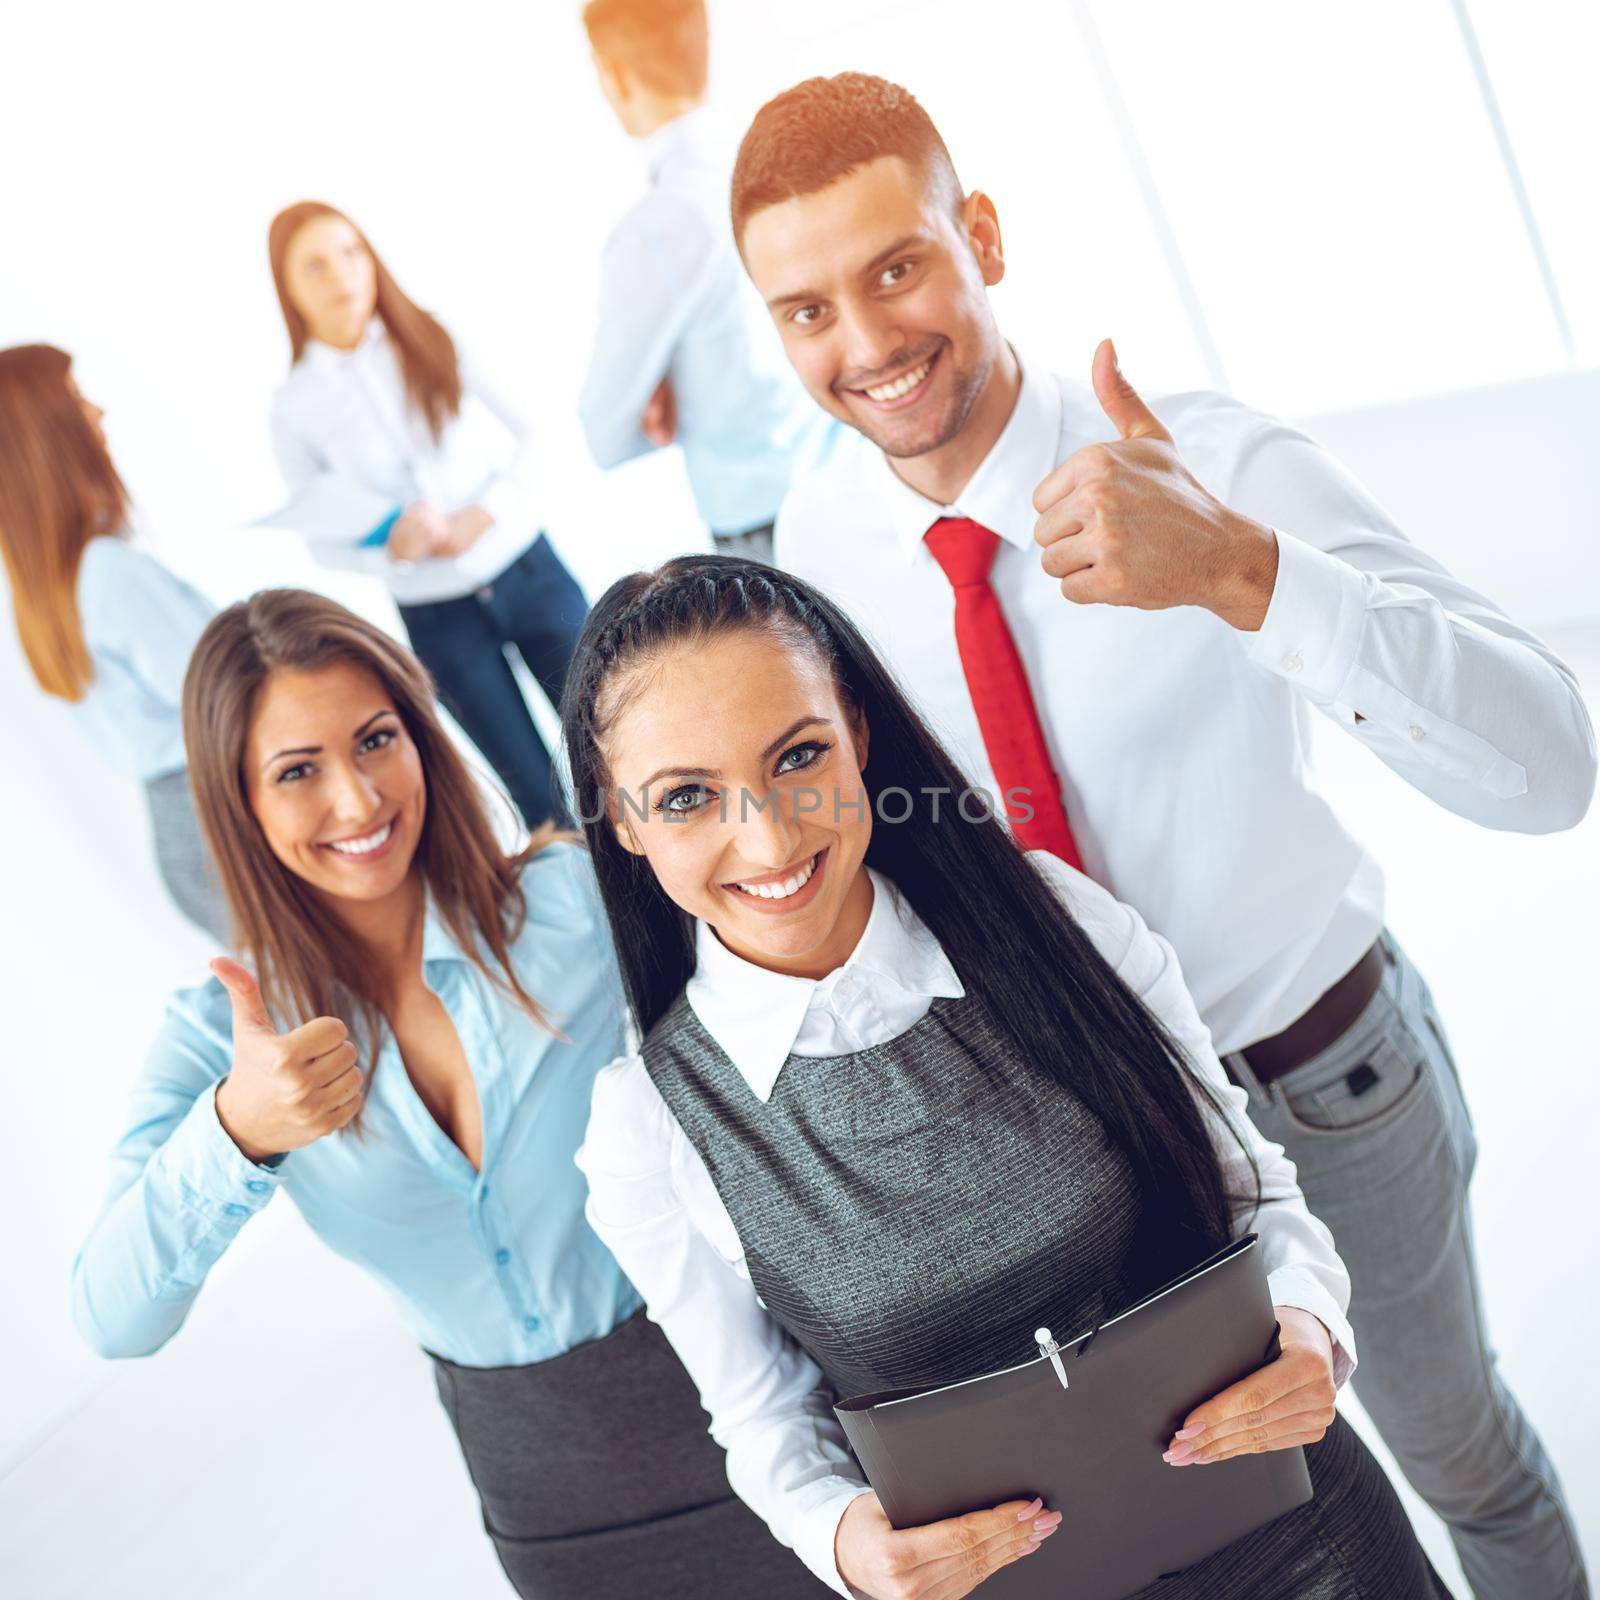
[730,72,962,238]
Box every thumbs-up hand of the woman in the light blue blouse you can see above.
[211,957,365,1165]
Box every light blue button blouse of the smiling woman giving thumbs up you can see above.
[72,843,640,1366]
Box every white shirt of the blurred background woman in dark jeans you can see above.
[264,317,541,605]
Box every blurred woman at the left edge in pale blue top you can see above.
[0,344,227,942]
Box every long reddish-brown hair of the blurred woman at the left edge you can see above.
[0,344,128,701]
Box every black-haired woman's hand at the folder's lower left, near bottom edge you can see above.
[834,1493,1061,1600]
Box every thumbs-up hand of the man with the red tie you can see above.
[1034,339,1278,632]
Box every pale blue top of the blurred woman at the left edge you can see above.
[72,534,216,779]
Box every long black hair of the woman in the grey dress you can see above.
[562,555,1259,1291]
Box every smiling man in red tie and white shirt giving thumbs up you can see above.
[731,74,1595,1600]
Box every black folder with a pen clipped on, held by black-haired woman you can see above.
[835,1234,1312,1600]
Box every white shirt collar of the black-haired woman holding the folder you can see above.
[686,867,966,1102]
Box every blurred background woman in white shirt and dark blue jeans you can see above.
[267,200,587,827]
